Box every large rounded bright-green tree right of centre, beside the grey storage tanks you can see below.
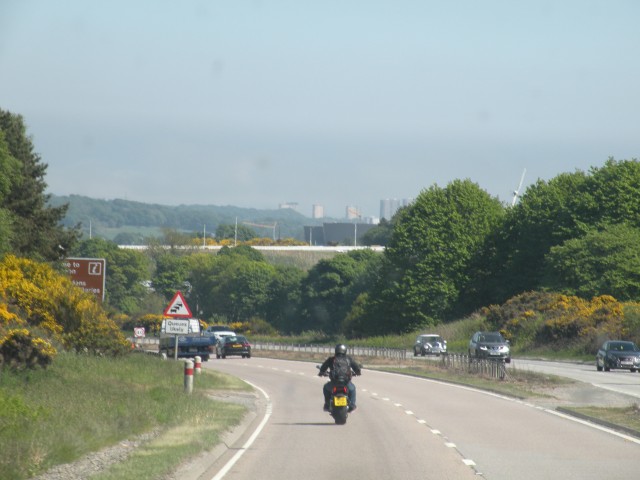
[367,180,504,333]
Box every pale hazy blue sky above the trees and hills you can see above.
[0,0,640,217]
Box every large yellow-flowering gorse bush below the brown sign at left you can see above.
[0,255,129,368]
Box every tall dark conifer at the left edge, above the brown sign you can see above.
[0,110,80,260]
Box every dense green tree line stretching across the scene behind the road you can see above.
[5,111,640,342]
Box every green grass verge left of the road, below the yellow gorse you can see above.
[0,353,250,480]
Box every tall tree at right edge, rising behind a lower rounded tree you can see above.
[482,158,640,303]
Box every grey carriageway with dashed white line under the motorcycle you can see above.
[198,357,640,480]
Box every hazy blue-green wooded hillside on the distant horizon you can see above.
[50,195,327,240]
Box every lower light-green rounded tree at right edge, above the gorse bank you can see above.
[544,224,640,301]
